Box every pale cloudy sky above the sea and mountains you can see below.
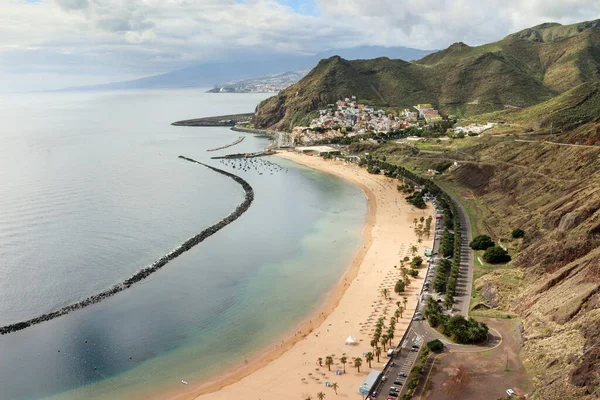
[0,0,600,92]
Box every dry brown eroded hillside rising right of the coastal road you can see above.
[357,130,600,400]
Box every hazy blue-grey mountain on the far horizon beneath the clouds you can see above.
[62,46,434,90]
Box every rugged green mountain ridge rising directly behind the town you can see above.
[256,20,600,129]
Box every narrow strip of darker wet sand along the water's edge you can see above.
[167,153,377,400]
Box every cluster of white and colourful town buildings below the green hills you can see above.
[290,96,494,145]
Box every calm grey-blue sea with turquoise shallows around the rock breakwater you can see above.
[0,90,366,400]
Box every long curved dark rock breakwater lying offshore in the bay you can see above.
[0,156,254,335]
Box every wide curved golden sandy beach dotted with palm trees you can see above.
[166,152,433,400]
